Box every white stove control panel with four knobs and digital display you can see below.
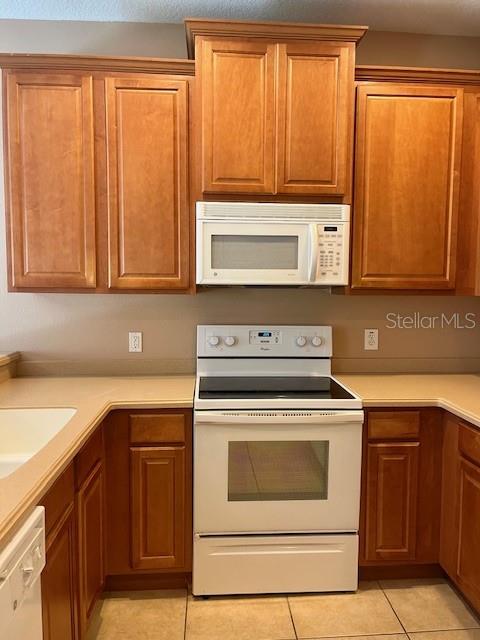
[197,325,332,358]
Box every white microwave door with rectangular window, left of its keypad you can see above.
[197,220,312,285]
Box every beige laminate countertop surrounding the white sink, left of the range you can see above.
[0,375,195,544]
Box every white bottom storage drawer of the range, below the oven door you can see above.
[192,534,358,596]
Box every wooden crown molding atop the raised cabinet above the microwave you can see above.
[184,18,368,58]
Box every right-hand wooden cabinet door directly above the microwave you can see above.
[277,43,355,195]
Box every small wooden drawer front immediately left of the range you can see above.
[130,413,185,444]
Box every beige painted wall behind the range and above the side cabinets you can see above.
[0,21,480,375]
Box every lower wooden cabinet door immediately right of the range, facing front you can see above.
[366,442,419,560]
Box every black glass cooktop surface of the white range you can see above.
[198,376,354,400]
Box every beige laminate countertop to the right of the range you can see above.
[336,374,480,427]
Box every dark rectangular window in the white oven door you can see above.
[228,440,329,502]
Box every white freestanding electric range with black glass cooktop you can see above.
[193,325,363,595]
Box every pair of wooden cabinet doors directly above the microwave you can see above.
[196,38,355,196]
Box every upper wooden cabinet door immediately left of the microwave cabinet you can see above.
[105,76,189,289]
